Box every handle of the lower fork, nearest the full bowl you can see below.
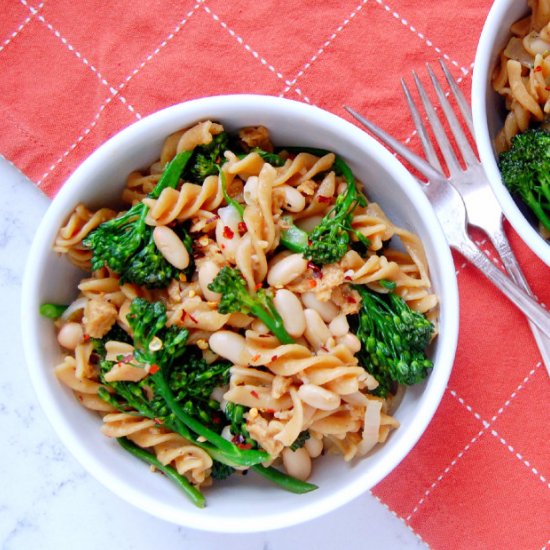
[456,237,550,337]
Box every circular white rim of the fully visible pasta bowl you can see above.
[21,94,459,533]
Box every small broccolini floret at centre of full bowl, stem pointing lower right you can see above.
[208,266,294,344]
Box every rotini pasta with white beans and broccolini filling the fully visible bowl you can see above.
[41,121,440,506]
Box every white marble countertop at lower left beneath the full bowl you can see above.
[0,157,425,550]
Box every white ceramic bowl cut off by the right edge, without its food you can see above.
[472,0,550,265]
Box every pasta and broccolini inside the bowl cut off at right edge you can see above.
[492,0,550,239]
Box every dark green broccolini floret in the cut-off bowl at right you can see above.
[498,128,550,230]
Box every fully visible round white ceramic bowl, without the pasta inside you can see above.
[22,95,458,532]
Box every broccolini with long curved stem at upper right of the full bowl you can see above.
[281,147,370,265]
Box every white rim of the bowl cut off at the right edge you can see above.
[472,0,550,266]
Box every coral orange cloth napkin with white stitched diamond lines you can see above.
[0,0,550,549]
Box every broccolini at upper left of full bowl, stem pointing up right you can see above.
[82,151,193,287]
